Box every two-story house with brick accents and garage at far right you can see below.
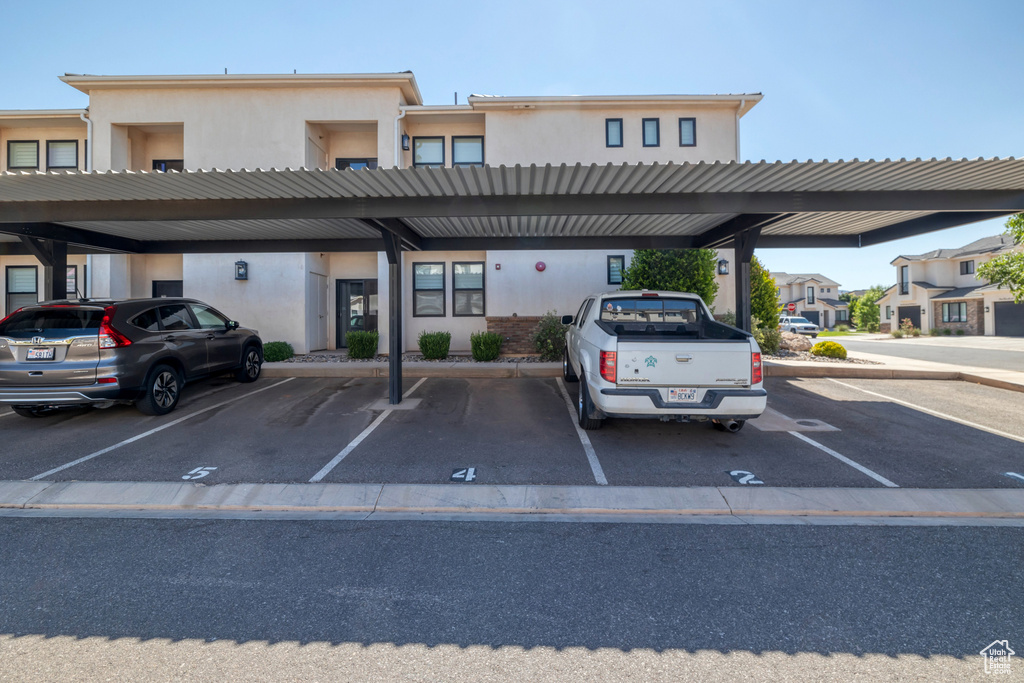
[878,234,1024,337]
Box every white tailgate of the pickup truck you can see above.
[615,339,751,387]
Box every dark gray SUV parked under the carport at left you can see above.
[0,299,263,417]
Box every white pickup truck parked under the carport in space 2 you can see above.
[562,290,768,432]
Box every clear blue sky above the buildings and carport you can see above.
[0,0,1024,289]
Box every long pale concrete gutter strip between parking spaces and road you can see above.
[0,481,1024,523]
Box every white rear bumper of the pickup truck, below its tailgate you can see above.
[594,387,768,420]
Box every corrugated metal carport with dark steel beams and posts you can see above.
[6,158,1024,403]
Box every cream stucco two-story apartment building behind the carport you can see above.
[0,72,761,352]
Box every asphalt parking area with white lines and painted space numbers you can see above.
[0,378,1024,488]
